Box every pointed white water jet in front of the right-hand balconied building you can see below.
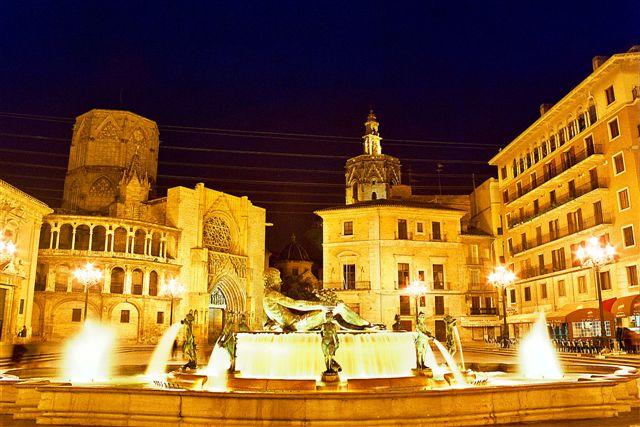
[518,311,563,379]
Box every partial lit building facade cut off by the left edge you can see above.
[0,181,52,343]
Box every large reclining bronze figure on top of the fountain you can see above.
[262,268,376,332]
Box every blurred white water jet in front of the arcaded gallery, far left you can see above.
[63,320,114,383]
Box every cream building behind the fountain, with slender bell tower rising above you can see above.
[316,113,498,339]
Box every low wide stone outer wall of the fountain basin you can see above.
[0,364,639,427]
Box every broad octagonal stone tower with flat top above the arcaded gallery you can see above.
[62,110,159,219]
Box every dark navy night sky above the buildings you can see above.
[0,0,640,254]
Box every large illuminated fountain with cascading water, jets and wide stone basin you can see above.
[0,272,640,427]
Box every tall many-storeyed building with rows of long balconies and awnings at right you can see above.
[489,47,640,337]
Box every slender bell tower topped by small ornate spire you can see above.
[345,110,400,205]
